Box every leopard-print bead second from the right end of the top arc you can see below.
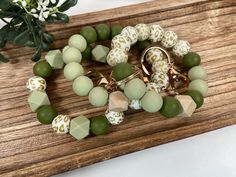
[161,31,178,48]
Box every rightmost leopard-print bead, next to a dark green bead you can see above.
[173,40,190,57]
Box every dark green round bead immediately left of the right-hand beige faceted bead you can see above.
[160,96,182,118]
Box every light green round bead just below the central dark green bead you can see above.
[124,78,147,100]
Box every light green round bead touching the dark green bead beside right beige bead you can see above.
[140,90,163,112]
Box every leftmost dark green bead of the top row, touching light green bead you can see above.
[80,26,97,44]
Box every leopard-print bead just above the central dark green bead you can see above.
[107,48,128,66]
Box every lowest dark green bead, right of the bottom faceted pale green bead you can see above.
[90,116,109,135]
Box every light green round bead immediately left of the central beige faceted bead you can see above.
[89,87,108,107]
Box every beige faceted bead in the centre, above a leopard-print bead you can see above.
[108,91,129,112]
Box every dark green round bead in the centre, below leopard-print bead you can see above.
[112,63,134,81]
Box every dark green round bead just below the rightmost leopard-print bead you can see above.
[183,52,201,68]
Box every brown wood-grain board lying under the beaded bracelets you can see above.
[0,0,236,177]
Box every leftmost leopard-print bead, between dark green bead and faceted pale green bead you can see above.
[26,76,47,92]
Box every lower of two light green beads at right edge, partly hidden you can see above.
[188,79,208,97]
